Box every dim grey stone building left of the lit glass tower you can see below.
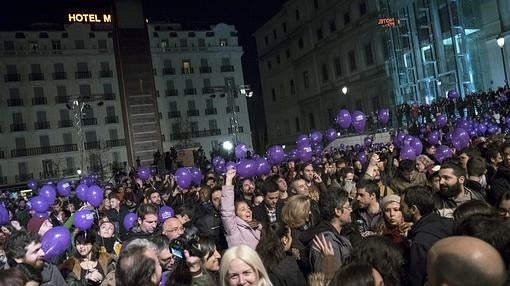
[254,0,393,145]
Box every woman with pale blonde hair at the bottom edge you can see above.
[220,245,273,286]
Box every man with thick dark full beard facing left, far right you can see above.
[434,162,485,218]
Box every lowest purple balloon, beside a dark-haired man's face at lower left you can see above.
[41,226,71,260]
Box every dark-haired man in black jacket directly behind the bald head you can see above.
[400,187,454,286]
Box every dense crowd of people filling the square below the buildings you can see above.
[0,88,510,286]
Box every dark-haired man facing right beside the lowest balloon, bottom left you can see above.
[5,230,67,286]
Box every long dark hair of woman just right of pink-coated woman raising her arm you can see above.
[257,222,290,272]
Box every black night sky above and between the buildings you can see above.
[0,0,285,151]
